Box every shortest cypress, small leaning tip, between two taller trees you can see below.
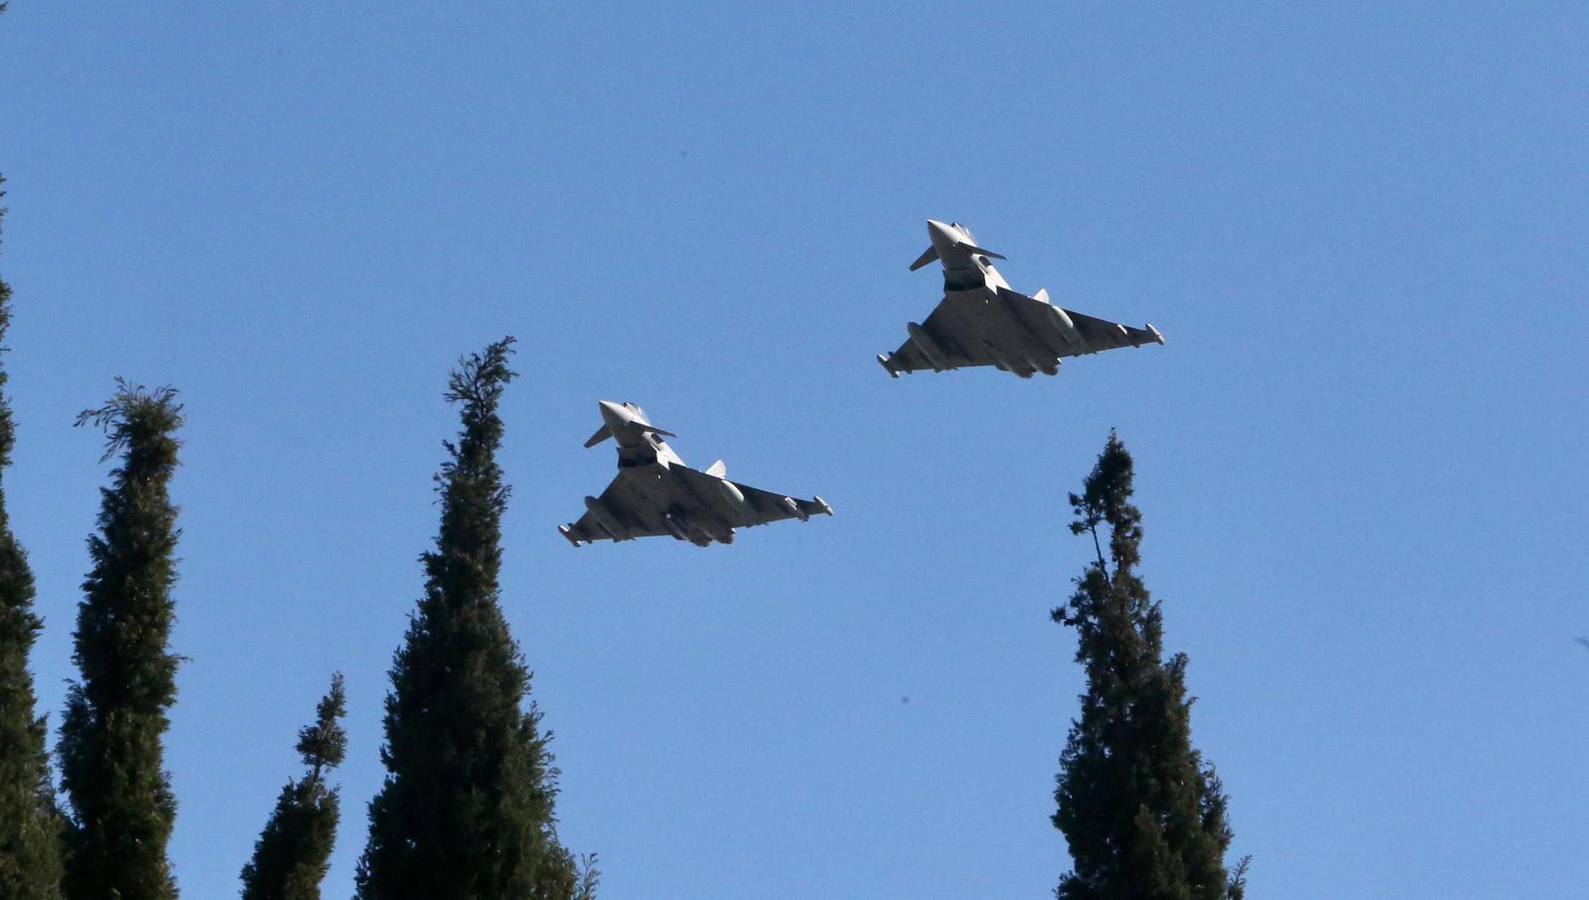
[243,673,348,900]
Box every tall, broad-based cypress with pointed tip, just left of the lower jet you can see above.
[358,339,577,900]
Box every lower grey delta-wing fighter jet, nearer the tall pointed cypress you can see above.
[558,401,833,547]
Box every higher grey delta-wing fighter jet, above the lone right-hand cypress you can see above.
[877,219,1165,378]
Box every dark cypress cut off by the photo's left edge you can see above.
[0,172,60,900]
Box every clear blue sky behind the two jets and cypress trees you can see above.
[0,0,1589,898]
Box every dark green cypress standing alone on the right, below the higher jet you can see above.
[1054,433,1246,900]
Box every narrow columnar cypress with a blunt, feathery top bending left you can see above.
[59,382,183,900]
